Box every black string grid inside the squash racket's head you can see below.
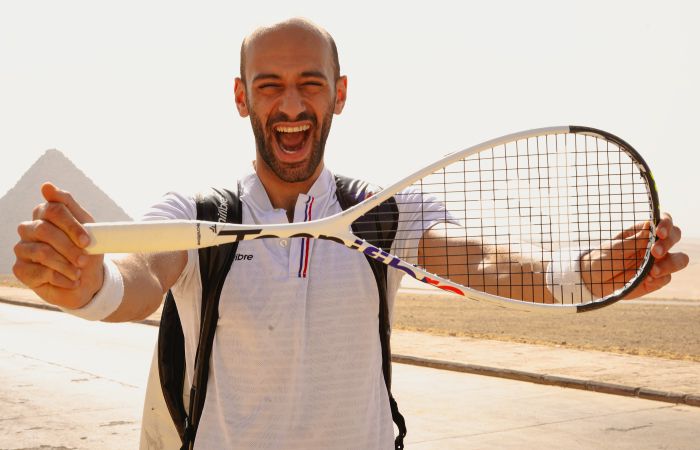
[352,133,653,303]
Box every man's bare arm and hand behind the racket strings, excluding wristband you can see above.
[418,214,688,303]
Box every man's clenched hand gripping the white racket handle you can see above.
[12,183,103,309]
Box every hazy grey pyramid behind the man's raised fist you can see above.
[0,150,131,274]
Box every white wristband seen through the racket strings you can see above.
[546,248,595,303]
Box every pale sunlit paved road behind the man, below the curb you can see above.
[0,304,700,450]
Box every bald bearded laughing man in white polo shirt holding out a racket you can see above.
[14,19,687,449]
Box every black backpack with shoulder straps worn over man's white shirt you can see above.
[157,175,406,450]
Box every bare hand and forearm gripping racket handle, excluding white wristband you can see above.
[13,183,187,322]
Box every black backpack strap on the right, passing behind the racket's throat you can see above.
[335,175,406,450]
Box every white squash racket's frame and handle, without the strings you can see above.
[84,125,660,313]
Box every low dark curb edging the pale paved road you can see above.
[0,297,700,407]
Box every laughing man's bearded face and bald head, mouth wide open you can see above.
[236,28,346,182]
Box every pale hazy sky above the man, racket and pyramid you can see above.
[0,0,700,237]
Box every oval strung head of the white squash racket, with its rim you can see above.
[348,126,660,312]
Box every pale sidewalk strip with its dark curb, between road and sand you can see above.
[0,286,700,406]
